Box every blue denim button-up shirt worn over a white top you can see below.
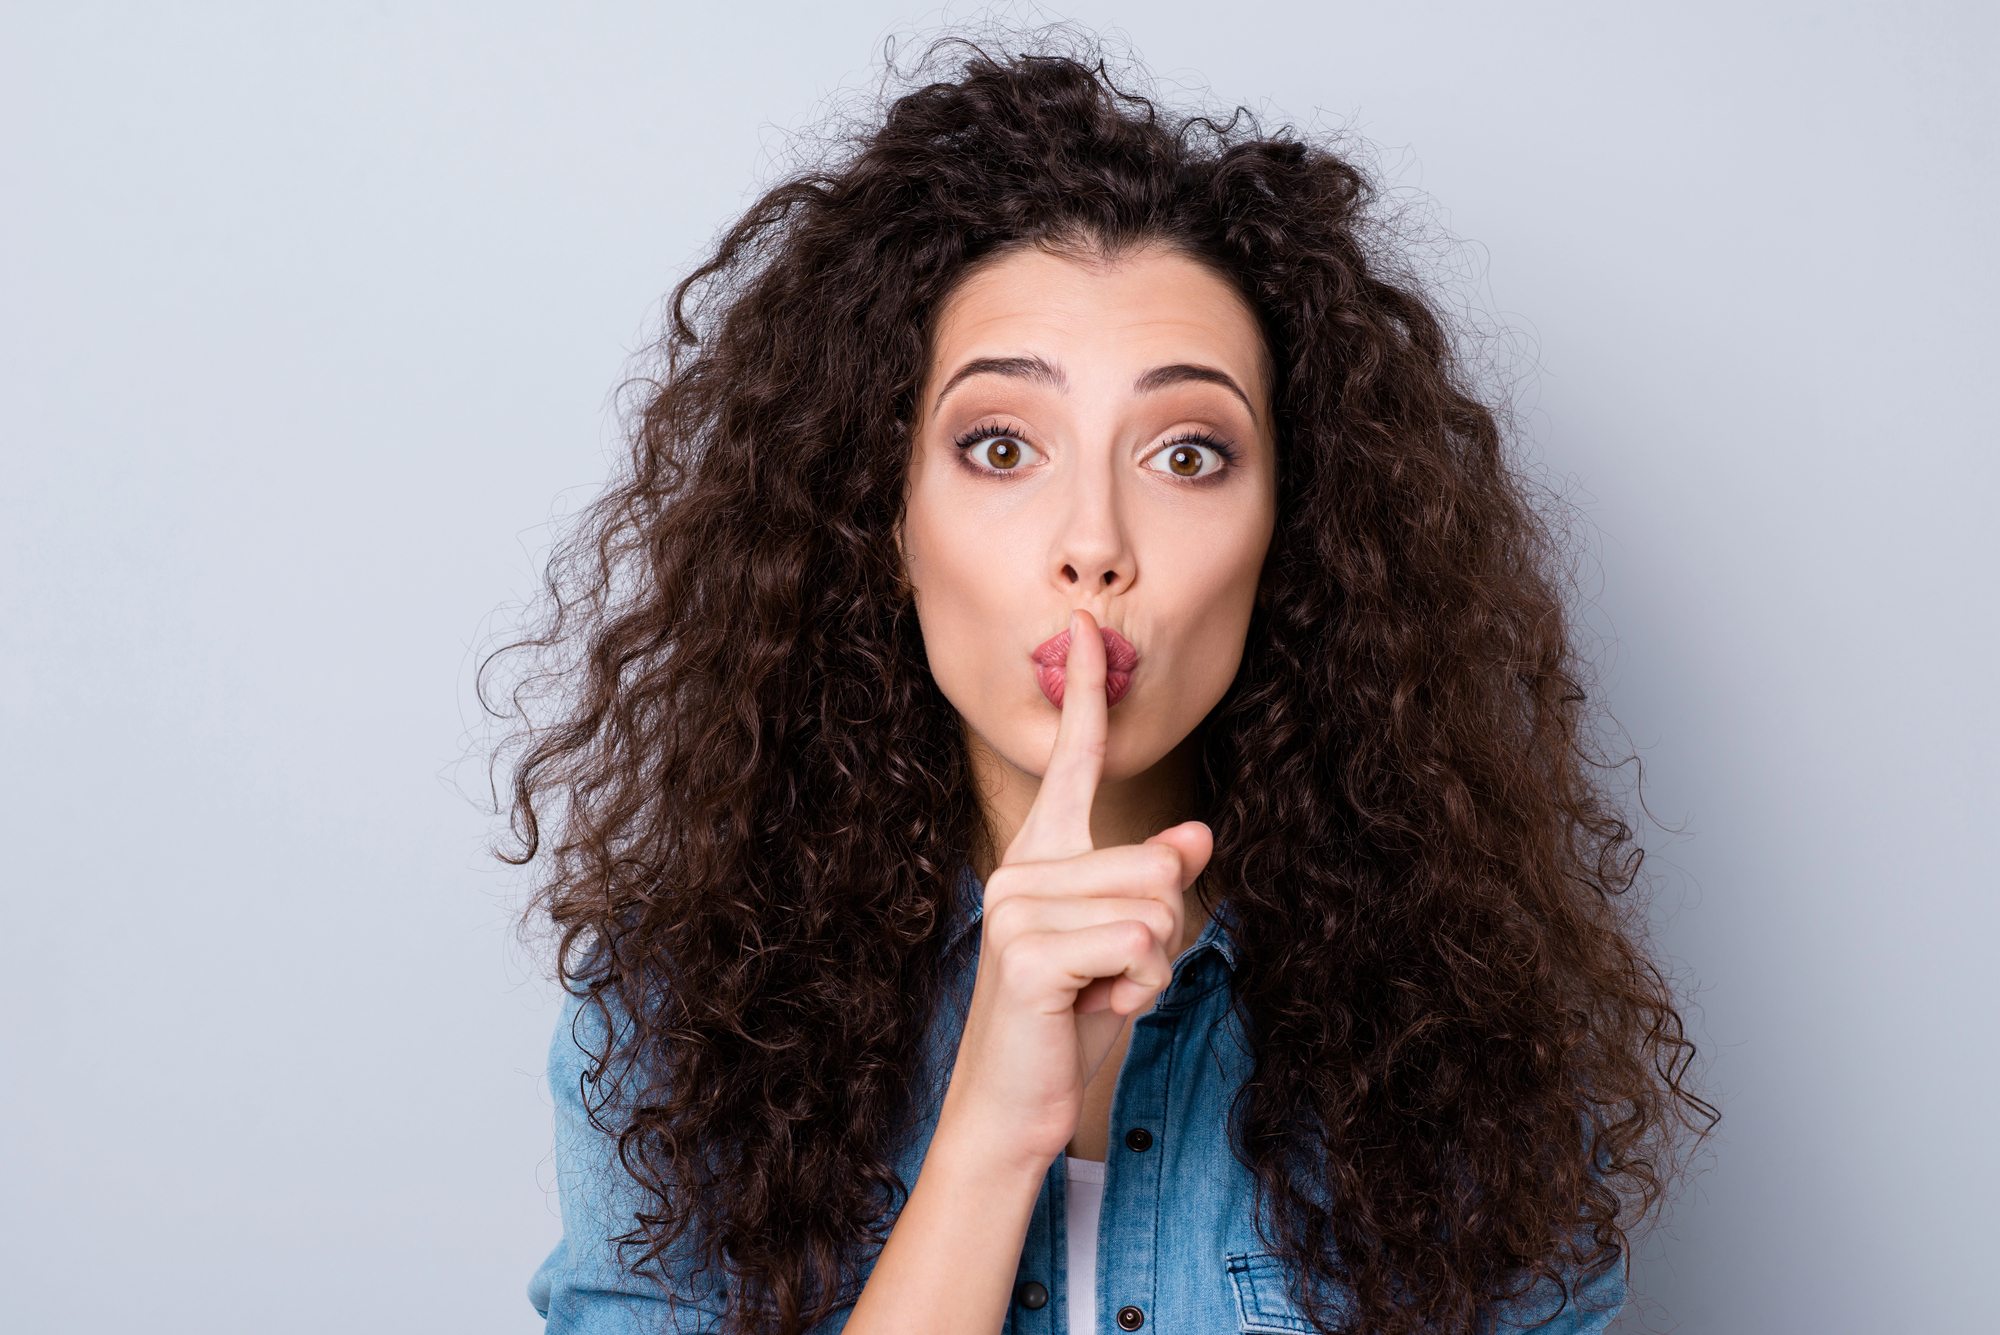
[528,883,1626,1335]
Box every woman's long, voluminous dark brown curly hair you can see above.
[492,36,1714,1335]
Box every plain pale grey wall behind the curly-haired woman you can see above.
[0,0,2000,1335]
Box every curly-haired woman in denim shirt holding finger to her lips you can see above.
[514,39,1706,1335]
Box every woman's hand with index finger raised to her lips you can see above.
[940,612,1214,1173]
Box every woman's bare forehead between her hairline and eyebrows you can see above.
[930,248,1268,394]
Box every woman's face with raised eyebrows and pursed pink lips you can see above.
[902,248,1276,783]
